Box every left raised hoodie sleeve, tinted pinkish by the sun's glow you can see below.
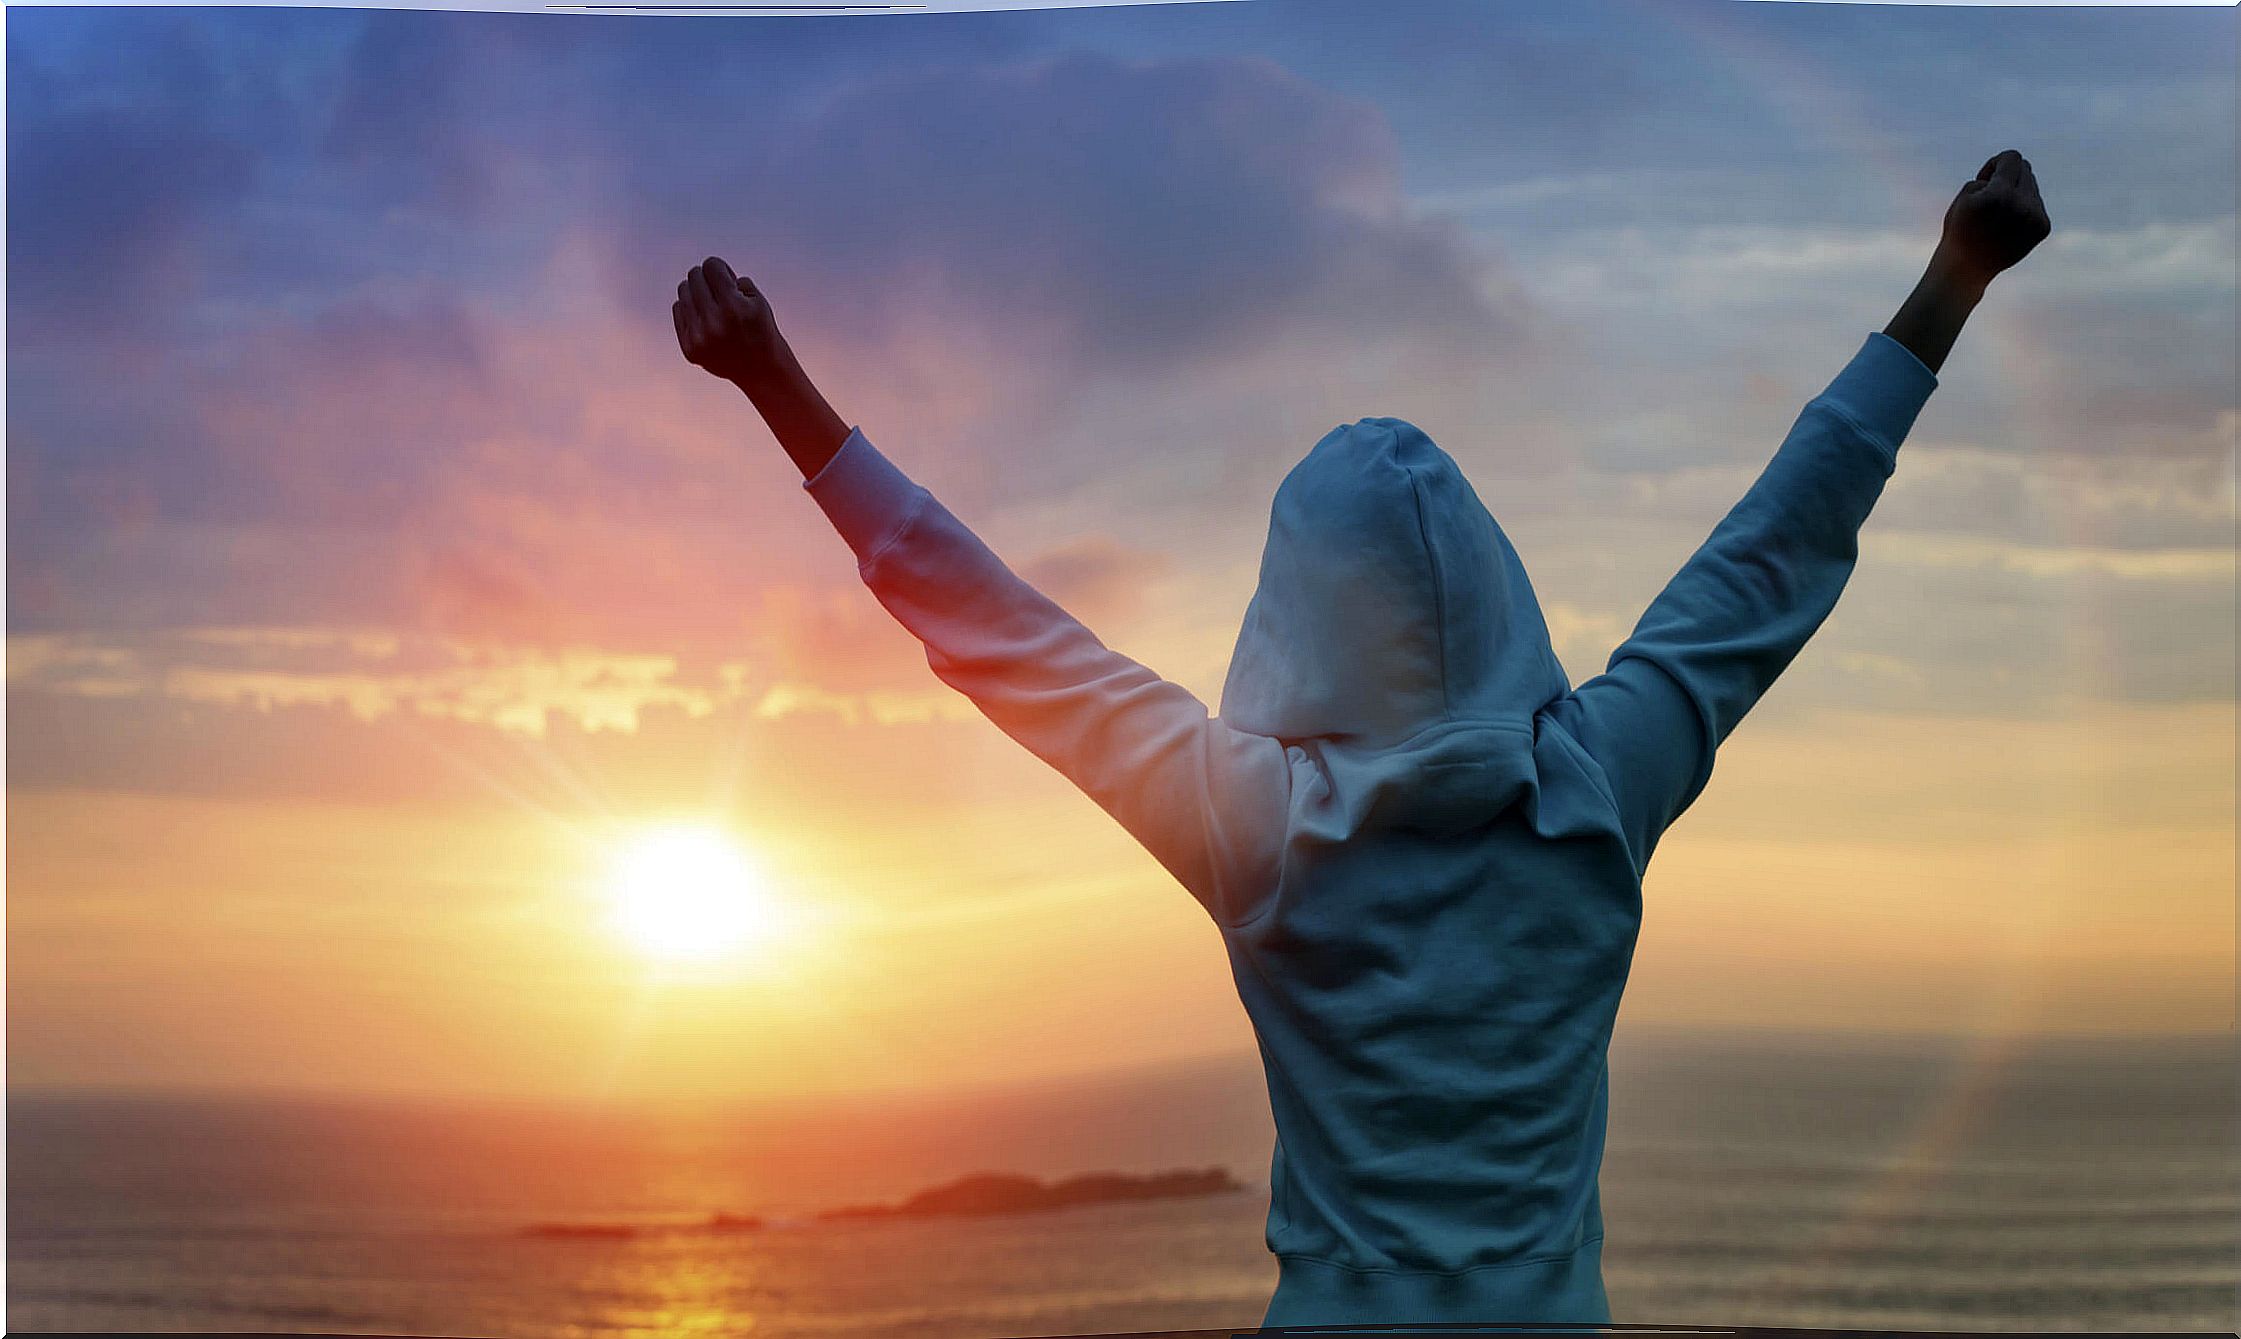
[802,428,1291,925]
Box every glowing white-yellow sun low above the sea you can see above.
[607,826,787,963]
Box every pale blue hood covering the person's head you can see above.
[1221,419,1571,743]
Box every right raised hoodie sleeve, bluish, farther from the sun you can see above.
[1564,331,1938,869]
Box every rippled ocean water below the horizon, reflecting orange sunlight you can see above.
[7,1028,2241,1339]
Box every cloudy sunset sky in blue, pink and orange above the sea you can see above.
[7,0,2237,1097]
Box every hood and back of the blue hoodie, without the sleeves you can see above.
[1221,419,1640,1323]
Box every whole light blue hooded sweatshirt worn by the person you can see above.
[805,334,1938,1326]
